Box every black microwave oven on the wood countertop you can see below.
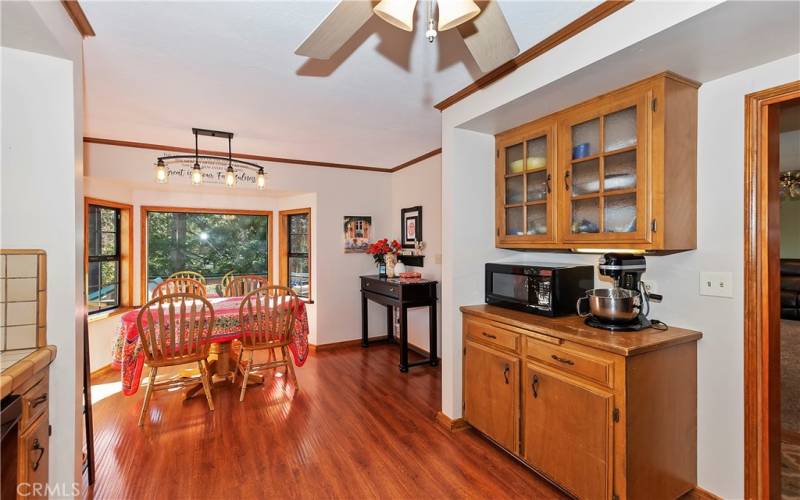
[486,263,594,316]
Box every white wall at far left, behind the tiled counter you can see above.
[0,1,84,496]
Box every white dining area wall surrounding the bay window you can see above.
[85,142,399,352]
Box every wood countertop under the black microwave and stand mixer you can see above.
[461,304,703,356]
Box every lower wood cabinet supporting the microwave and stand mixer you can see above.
[462,306,700,500]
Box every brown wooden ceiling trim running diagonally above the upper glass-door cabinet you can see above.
[434,0,633,111]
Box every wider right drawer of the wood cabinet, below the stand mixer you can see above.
[525,338,614,387]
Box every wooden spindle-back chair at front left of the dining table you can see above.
[136,293,214,426]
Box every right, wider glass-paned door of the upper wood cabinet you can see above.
[562,95,646,241]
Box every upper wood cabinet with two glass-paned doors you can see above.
[495,73,698,253]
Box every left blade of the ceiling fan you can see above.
[294,0,372,59]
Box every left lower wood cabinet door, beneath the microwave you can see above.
[464,340,520,452]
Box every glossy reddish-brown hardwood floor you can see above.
[86,345,564,499]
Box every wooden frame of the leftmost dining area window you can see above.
[83,196,133,318]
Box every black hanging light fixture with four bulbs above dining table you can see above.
[156,128,267,190]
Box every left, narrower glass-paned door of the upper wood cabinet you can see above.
[498,129,553,241]
